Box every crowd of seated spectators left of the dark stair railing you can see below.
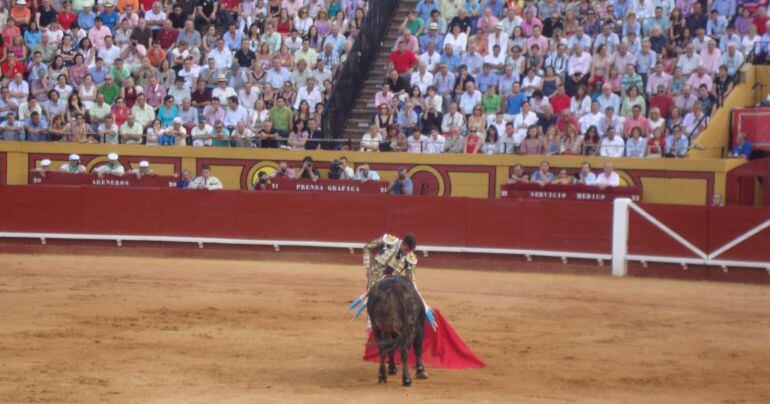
[0,0,368,149]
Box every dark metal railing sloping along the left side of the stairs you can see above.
[321,0,399,138]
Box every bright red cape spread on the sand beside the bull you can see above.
[364,309,486,369]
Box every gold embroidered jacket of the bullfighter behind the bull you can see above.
[364,234,417,290]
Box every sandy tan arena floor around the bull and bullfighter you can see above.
[0,255,770,403]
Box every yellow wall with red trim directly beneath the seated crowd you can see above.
[0,142,743,205]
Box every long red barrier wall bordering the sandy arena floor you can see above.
[0,186,770,262]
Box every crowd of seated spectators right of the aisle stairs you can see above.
[361,0,770,157]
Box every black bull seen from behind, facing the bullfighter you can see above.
[367,276,427,386]
